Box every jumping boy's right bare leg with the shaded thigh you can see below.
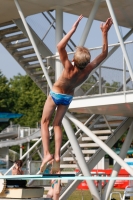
[52,105,68,172]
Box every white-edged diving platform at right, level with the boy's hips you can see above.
[69,91,133,117]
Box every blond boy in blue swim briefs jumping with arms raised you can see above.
[40,15,113,173]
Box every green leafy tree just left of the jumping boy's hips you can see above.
[10,74,46,128]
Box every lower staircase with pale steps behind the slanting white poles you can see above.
[60,116,126,171]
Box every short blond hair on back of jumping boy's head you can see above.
[73,46,91,69]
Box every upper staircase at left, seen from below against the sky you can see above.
[0,20,55,94]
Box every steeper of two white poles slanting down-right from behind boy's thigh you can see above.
[62,117,100,200]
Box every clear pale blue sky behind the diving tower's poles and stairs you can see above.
[0,13,131,79]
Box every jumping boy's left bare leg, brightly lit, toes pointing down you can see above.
[40,95,56,172]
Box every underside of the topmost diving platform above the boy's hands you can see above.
[0,0,133,28]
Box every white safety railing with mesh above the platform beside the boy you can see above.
[43,41,133,95]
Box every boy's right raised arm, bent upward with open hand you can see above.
[89,18,113,71]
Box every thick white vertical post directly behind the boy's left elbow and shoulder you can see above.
[55,8,63,80]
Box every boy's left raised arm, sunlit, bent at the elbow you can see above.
[57,15,83,67]
